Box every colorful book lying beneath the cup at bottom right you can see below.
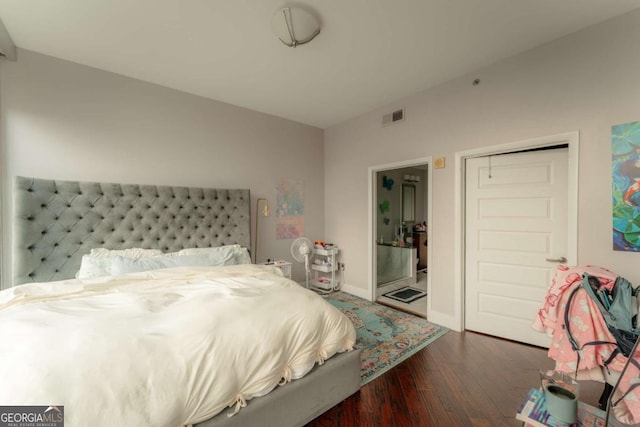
[516,388,622,427]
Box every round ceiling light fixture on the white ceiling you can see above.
[271,7,320,47]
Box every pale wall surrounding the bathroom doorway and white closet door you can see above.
[325,7,640,328]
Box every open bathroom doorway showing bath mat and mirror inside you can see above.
[370,158,431,317]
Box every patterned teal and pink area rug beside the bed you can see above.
[325,292,449,385]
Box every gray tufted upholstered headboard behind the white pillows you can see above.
[13,177,251,285]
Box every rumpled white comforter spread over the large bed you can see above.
[0,265,355,426]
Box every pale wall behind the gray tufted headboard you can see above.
[0,50,324,287]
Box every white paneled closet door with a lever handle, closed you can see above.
[465,148,568,347]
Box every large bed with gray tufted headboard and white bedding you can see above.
[0,177,360,426]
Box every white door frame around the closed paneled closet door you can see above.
[452,131,580,331]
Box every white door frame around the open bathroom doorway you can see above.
[368,156,433,310]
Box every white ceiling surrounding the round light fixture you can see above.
[0,0,640,128]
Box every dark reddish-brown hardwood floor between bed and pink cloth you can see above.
[307,331,603,427]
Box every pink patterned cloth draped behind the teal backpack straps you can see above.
[533,265,640,425]
